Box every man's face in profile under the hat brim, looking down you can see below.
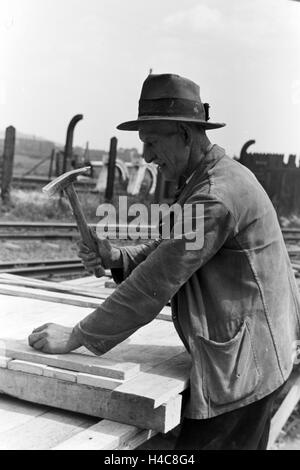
[139,121,189,181]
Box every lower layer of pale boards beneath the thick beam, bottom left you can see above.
[0,395,156,450]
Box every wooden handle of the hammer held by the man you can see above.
[64,183,105,277]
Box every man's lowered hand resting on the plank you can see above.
[28,323,82,354]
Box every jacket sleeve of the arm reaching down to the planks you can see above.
[74,195,235,354]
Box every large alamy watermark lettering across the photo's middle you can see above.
[96,196,204,250]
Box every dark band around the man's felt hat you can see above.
[139,98,206,120]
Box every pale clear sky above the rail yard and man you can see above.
[0,0,300,156]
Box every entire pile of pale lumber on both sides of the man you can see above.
[0,275,300,450]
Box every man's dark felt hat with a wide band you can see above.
[117,74,225,131]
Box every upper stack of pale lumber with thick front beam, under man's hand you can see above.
[0,277,190,433]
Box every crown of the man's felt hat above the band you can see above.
[141,73,201,102]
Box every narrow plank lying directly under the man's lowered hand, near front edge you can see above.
[0,339,140,380]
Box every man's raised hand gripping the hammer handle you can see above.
[77,226,122,274]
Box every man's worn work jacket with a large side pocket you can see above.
[75,145,300,419]
